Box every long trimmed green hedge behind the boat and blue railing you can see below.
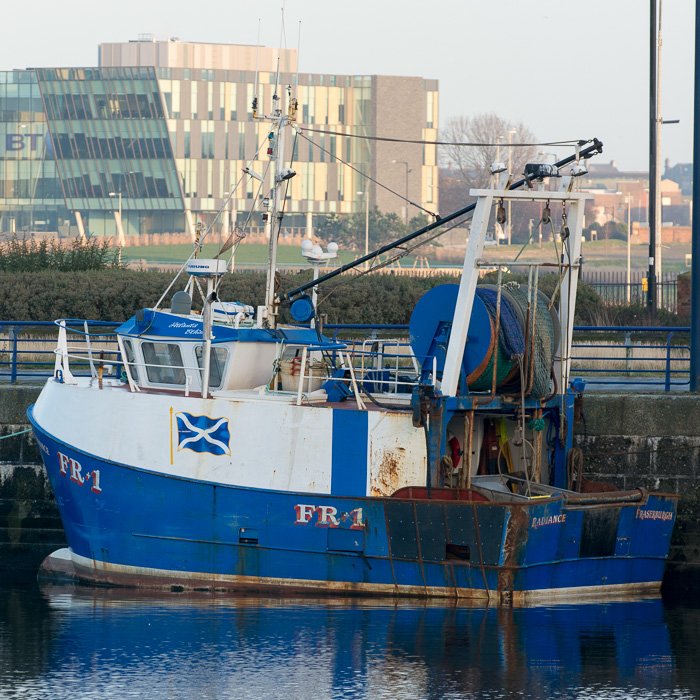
[0,269,600,324]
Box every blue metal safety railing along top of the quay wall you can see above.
[0,320,690,391]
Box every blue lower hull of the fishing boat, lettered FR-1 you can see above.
[28,408,676,600]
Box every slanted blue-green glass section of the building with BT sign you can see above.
[0,68,185,235]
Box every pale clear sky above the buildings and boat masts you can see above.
[0,0,695,170]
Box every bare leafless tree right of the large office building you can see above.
[440,114,537,194]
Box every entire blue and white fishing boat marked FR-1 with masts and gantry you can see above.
[28,89,677,601]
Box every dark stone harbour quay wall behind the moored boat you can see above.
[0,385,700,591]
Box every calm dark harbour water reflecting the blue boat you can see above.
[0,582,700,700]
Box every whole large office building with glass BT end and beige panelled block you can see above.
[0,40,438,243]
